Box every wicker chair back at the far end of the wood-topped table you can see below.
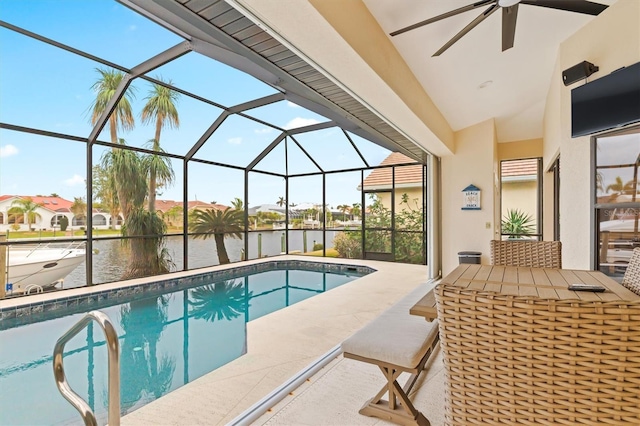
[491,240,562,268]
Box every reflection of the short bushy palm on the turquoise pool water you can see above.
[189,280,251,322]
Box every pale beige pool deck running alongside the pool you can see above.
[112,256,443,426]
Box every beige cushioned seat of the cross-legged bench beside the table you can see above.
[342,284,438,369]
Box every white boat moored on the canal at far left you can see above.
[6,242,86,294]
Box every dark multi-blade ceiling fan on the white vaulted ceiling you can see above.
[389,0,609,56]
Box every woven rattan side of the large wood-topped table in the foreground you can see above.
[436,284,640,426]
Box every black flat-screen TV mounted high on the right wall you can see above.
[571,62,640,138]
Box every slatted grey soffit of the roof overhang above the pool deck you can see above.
[118,0,428,163]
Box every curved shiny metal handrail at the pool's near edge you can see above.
[53,311,120,426]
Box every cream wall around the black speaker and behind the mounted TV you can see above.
[544,0,640,269]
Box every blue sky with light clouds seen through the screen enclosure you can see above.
[0,0,396,207]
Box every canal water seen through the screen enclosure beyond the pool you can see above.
[62,230,339,289]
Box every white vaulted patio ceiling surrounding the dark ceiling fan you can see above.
[363,0,616,142]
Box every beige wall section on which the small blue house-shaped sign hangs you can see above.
[442,120,499,275]
